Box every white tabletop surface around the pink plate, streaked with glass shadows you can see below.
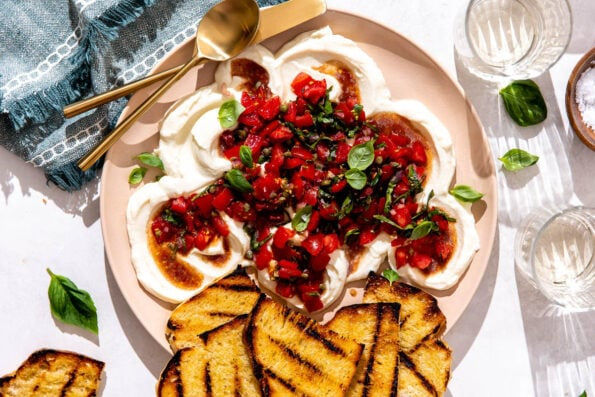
[0,0,595,397]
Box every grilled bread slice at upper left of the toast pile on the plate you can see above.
[165,267,260,353]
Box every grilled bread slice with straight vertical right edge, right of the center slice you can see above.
[326,303,400,397]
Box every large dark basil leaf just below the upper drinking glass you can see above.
[500,80,547,127]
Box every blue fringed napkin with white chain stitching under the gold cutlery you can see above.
[0,0,284,191]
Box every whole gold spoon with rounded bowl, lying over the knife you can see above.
[77,0,260,171]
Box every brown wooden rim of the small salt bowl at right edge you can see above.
[566,48,595,151]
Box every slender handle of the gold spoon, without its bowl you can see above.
[77,56,207,171]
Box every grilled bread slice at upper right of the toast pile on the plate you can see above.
[364,273,446,352]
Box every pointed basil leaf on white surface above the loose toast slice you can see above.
[47,269,98,334]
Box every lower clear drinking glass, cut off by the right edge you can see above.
[516,207,595,309]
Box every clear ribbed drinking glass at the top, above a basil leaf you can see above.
[454,0,572,81]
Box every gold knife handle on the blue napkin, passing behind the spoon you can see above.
[64,65,184,118]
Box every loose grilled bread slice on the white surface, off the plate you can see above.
[0,349,104,397]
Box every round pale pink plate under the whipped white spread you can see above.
[101,11,498,349]
